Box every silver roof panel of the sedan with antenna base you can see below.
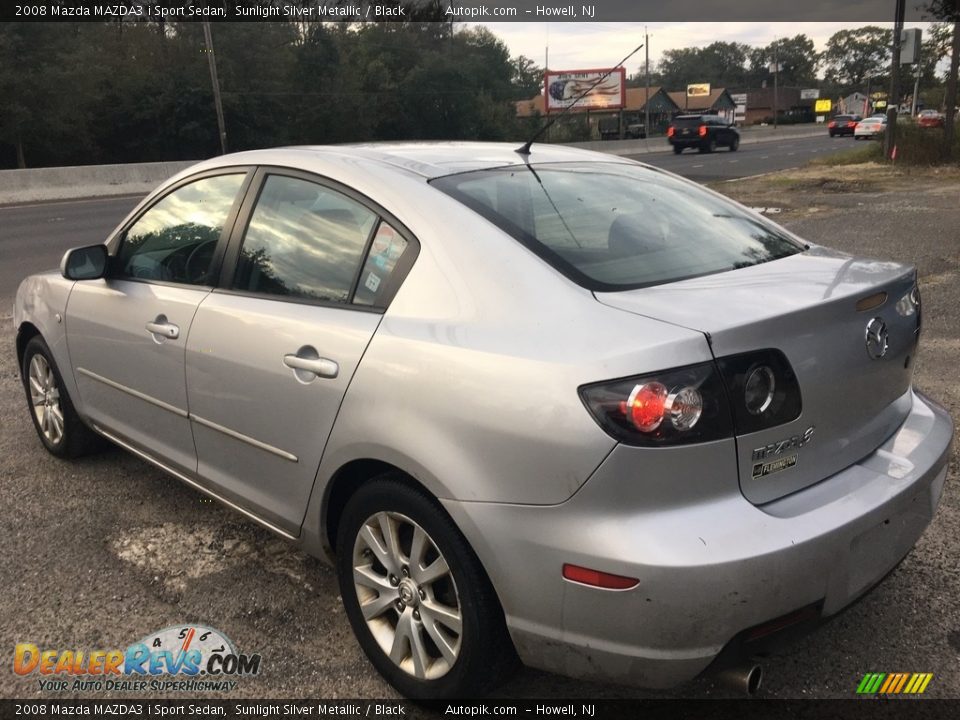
[182,141,630,179]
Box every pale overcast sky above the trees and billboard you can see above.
[474,22,927,75]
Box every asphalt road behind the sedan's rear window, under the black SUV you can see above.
[626,131,864,182]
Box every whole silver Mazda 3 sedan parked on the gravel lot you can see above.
[15,143,953,697]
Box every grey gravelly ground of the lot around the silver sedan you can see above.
[0,167,960,699]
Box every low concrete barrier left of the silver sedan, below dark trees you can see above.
[0,160,197,205]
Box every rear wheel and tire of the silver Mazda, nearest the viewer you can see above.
[337,473,517,699]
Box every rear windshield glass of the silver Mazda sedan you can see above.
[431,162,804,291]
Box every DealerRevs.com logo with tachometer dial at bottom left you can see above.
[13,625,261,692]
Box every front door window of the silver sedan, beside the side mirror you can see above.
[116,173,245,285]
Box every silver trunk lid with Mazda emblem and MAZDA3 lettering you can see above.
[595,247,919,504]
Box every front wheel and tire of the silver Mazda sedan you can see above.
[20,335,104,458]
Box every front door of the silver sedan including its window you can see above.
[66,168,248,472]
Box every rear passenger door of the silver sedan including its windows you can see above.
[187,169,415,535]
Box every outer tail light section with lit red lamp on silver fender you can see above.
[580,362,733,447]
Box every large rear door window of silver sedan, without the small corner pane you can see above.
[233,175,377,302]
